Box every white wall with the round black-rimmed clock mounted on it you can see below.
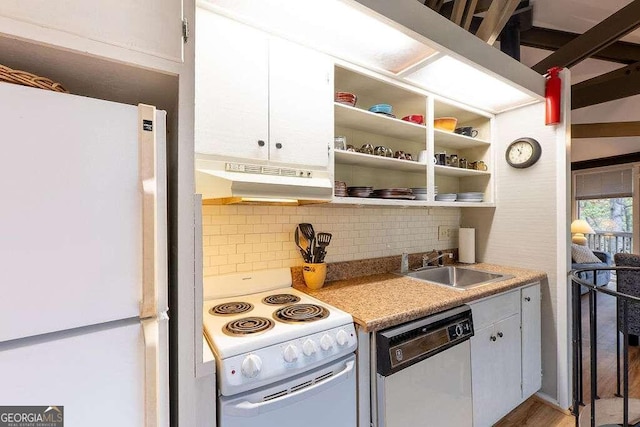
[462,103,568,399]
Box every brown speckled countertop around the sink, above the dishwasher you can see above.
[295,263,547,332]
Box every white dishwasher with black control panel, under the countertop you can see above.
[376,305,473,427]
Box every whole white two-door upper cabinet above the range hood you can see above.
[195,9,333,168]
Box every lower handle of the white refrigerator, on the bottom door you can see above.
[141,319,161,427]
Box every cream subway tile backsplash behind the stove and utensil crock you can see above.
[202,205,461,276]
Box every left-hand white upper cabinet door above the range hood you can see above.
[195,8,269,160]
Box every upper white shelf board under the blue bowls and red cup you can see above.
[334,102,427,145]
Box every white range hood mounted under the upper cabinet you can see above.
[196,156,333,204]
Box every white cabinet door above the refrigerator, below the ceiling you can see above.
[0,0,183,62]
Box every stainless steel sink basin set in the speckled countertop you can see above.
[404,267,513,290]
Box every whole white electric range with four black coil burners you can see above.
[203,268,357,427]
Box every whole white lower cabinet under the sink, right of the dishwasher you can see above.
[469,283,542,427]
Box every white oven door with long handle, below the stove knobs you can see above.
[219,354,357,427]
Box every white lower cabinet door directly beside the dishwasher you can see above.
[471,315,521,427]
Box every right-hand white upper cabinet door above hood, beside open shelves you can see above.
[269,38,333,167]
